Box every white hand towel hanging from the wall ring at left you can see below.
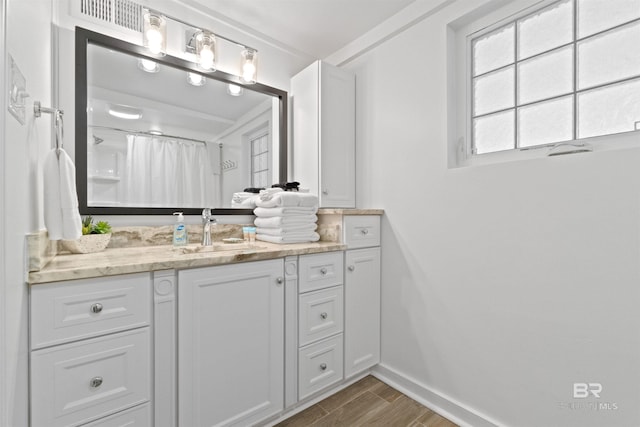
[43,149,82,240]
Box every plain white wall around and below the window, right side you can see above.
[335,0,640,427]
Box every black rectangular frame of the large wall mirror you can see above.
[75,27,288,215]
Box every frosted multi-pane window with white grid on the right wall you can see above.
[470,0,640,154]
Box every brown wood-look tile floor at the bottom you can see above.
[276,375,458,427]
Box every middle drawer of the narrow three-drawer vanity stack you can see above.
[299,286,344,346]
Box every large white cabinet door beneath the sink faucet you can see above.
[178,259,284,426]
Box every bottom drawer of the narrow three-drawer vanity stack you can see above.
[298,334,343,400]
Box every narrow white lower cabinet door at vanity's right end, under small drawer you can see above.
[344,248,380,378]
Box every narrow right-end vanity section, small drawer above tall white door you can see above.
[343,215,380,378]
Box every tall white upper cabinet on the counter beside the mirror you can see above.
[291,61,356,208]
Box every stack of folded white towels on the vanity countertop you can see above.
[253,188,320,243]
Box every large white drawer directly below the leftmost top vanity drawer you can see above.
[31,327,151,427]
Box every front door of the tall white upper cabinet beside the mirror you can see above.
[319,62,356,208]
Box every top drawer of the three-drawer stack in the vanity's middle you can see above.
[298,251,344,292]
